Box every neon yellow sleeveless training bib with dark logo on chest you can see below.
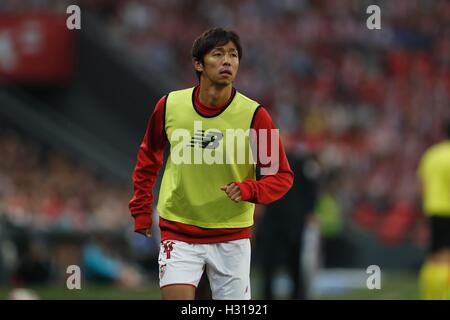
[157,88,259,228]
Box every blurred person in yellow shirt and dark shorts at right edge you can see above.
[418,119,450,300]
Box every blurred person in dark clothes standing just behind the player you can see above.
[255,138,320,300]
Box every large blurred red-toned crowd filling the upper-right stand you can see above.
[102,0,450,246]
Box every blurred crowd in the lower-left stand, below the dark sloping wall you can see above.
[0,131,131,232]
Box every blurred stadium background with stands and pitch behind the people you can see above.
[0,0,450,299]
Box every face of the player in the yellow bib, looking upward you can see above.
[199,41,239,86]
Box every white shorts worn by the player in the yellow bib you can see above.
[158,239,251,300]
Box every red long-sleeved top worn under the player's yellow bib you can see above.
[129,87,294,243]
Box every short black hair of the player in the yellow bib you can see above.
[192,28,242,80]
